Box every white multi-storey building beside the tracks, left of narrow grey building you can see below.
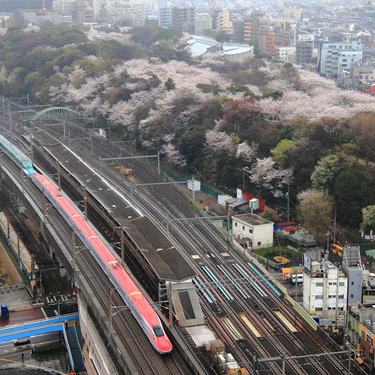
[303,260,348,326]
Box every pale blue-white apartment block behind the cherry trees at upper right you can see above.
[319,41,363,79]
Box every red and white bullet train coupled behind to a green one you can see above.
[32,170,173,354]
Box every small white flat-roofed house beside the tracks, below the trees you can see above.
[232,214,273,249]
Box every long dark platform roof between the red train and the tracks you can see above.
[34,130,195,282]
